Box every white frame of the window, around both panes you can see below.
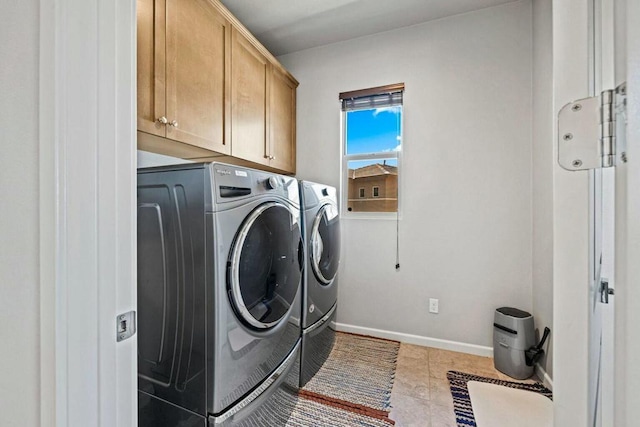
[340,88,404,220]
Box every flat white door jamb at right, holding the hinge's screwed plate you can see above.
[553,0,590,426]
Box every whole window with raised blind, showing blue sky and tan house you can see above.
[340,83,404,218]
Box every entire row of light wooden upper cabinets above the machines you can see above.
[138,0,298,174]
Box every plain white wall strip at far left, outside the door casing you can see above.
[0,0,40,427]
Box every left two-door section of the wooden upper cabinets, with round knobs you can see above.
[138,0,231,154]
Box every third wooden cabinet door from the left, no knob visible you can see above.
[231,29,269,165]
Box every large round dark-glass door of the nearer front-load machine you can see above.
[227,202,302,330]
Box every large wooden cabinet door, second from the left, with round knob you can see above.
[165,0,231,154]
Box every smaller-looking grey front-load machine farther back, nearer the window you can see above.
[299,180,340,387]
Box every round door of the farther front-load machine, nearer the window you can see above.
[310,203,340,285]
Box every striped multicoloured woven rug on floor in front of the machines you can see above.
[287,332,400,427]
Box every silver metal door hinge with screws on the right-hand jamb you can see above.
[558,83,627,171]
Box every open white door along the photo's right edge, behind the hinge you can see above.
[589,0,640,427]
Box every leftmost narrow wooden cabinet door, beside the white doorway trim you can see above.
[137,0,166,136]
